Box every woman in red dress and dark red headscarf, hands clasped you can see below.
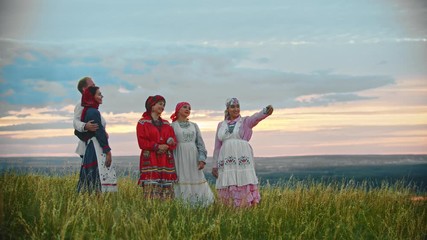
[136,95,177,199]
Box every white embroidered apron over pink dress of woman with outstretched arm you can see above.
[216,118,258,189]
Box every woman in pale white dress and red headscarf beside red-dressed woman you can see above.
[171,102,214,206]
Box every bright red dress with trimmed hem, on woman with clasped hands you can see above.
[136,117,177,186]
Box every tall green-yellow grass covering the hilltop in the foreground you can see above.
[0,173,427,239]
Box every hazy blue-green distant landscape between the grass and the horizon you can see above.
[0,155,427,192]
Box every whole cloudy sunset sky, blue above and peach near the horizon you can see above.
[0,0,427,157]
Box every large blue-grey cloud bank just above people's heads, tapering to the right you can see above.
[0,40,395,113]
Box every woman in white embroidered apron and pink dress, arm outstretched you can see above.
[212,98,273,207]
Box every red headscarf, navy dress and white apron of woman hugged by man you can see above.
[76,87,117,193]
